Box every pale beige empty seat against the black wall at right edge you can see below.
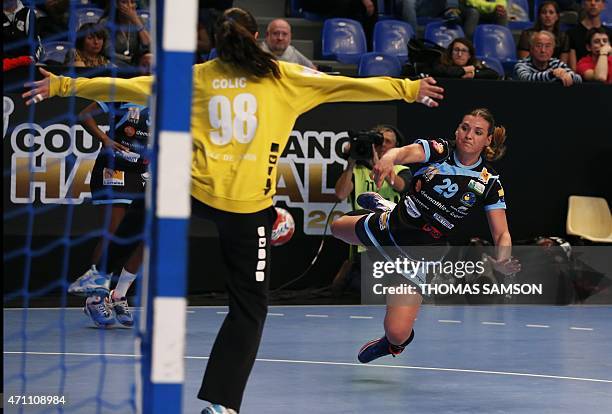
[565,196,612,243]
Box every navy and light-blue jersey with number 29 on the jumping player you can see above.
[391,139,506,244]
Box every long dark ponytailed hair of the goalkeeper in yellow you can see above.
[215,7,280,78]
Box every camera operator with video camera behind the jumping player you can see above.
[332,125,412,294]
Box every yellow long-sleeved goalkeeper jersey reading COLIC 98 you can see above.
[50,59,420,213]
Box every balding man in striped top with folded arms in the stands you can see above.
[514,30,582,87]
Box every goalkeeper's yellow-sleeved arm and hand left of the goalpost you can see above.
[22,68,153,105]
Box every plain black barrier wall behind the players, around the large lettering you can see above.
[3,72,612,293]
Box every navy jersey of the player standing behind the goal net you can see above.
[97,102,151,172]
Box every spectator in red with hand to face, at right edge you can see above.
[576,27,612,84]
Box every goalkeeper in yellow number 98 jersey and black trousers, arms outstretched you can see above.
[23,8,443,413]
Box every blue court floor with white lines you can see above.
[4,306,612,414]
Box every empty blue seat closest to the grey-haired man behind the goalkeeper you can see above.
[321,18,367,63]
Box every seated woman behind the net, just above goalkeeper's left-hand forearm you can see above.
[66,23,112,68]
